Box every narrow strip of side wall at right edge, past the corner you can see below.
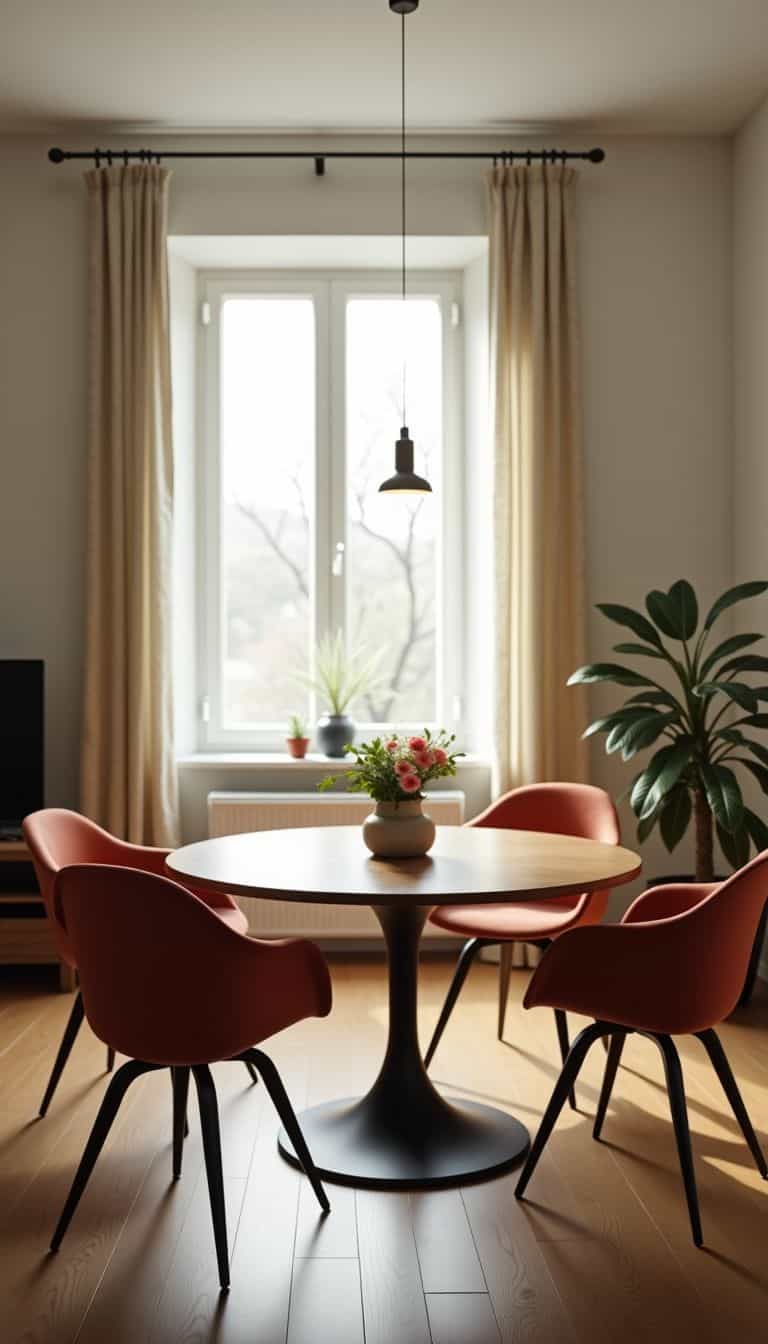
[733,101,768,976]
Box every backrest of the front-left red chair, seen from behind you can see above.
[54,864,256,1063]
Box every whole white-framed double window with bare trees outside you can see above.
[199,273,461,750]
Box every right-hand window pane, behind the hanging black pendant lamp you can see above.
[347,297,443,723]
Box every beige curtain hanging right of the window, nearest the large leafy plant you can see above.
[490,164,586,792]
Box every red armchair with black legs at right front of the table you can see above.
[515,851,768,1246]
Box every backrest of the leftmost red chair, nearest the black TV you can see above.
[23,808,123,966]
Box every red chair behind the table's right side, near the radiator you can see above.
[424,784,621,1106]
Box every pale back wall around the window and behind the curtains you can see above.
[0,137,730,903]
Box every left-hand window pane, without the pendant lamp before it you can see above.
[221,297,315,728]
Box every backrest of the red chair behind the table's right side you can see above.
[467,784,621,923]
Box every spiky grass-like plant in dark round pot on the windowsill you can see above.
[299,630,381,757]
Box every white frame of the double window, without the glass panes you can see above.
[196,270,464,753]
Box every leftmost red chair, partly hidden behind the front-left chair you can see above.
[23,808,250,1116]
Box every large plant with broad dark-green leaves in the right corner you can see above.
[568,579,768,882]
